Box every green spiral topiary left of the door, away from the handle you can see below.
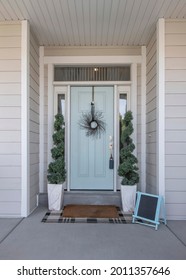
[47,114,66,184]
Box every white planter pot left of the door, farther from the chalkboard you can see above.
[48,184,64,211]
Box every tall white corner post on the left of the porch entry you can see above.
[21,20,30,217]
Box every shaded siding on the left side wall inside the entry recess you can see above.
[29,29,39,212]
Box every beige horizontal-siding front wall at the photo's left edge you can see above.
[0,22,21,216]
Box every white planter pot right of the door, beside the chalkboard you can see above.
[121,185,137,213]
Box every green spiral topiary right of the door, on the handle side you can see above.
[118,111,139,185]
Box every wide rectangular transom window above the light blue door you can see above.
[54,65,131,82]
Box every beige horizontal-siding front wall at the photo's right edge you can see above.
[165,21,186,219]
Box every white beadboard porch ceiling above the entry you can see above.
[0,0,186,46]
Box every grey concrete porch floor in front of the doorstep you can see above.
[0,206,186,260]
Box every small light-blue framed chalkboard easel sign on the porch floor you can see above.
[132,192,167,230]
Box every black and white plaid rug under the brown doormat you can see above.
[42,207,132,224]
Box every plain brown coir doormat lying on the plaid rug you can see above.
[62,204,119,219]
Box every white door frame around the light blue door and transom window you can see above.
[40,52,146,191]
